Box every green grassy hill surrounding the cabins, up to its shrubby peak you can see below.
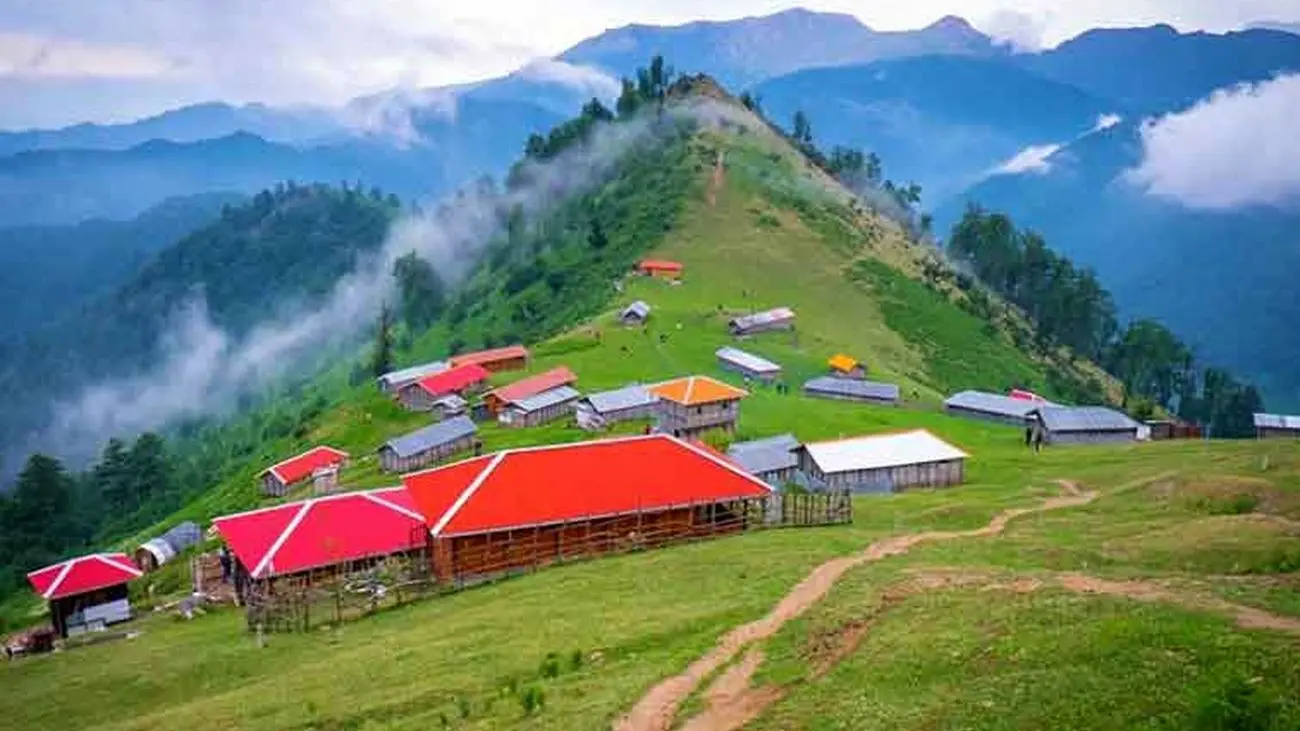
[0,80,1300,731]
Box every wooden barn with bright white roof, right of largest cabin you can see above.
[798,429,969,493]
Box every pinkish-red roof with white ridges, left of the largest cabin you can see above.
[212,488,424,579]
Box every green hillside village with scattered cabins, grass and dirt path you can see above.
[0,55,1300,731]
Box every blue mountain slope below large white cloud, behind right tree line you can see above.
[936,122,1300,408]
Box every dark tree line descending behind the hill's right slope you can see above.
[948,206,1264,437]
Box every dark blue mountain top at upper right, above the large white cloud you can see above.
[1015,25,1300,114]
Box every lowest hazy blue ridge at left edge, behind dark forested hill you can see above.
[0,193,243,339]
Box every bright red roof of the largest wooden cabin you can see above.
[402,434,771,536]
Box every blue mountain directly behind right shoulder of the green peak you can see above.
[755,56,1121,200]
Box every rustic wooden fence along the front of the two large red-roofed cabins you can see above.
[243,492,853,632]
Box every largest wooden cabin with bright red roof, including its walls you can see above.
[402,434,771,580]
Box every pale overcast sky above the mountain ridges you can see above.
[0,0,1300,129]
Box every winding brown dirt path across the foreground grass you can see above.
[614,481,1097,731]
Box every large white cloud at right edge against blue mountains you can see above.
[1126,74,1300,211]
